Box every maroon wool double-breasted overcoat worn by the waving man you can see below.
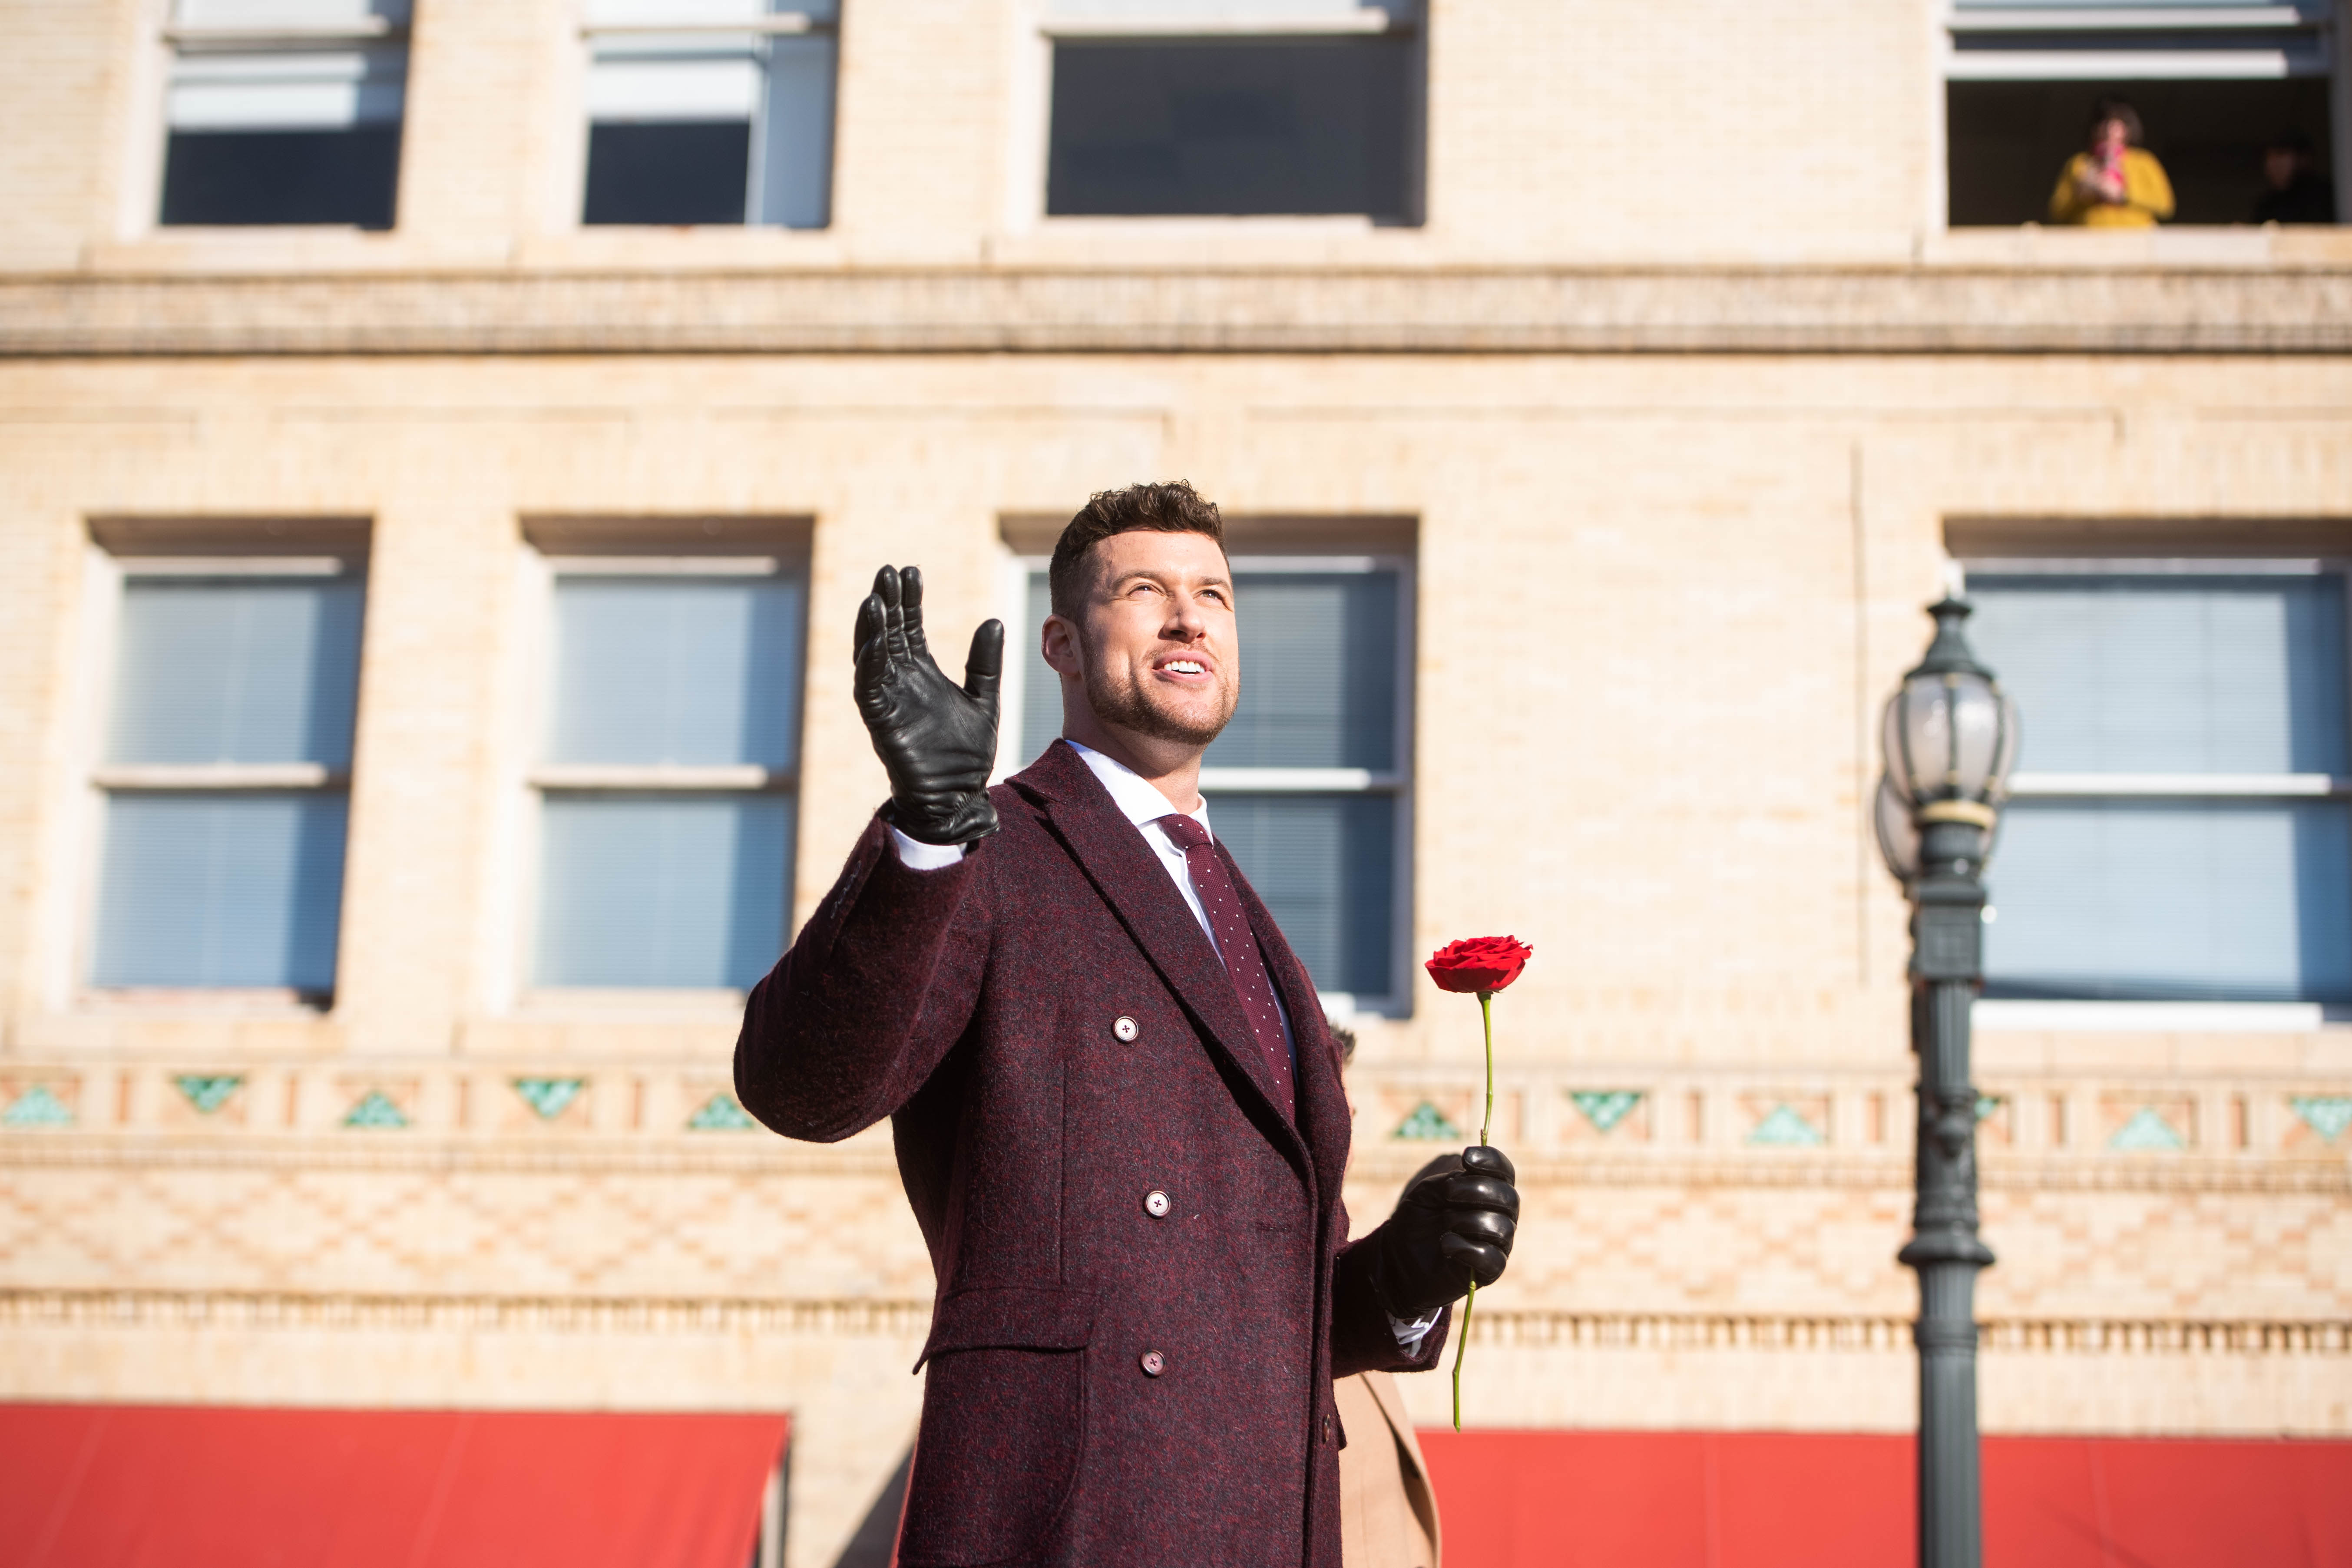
[736,743,1444,1568]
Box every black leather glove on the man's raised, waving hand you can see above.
[856,566,1004,844]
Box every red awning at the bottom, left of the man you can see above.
[0,1406,786,1568]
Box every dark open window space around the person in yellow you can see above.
[1945,78,2331,228]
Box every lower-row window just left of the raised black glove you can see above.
[532,555,804,990]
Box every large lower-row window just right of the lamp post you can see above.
[1968,559,2352,1002]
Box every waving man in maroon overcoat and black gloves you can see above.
[736,484,1519,1568]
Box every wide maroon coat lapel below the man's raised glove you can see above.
[1009,741,1322,1166]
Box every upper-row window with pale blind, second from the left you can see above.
[581,0,837,228]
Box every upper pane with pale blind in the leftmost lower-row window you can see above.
[106,576,362,769]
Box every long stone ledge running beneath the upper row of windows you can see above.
[0,266,2352,357]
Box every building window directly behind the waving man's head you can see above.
[1019,555,1413,1011]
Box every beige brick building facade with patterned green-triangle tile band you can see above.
[0,0,2352,1568]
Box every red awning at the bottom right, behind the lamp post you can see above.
[1421,1429,2352,1568]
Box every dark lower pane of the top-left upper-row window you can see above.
[162,122,400,228]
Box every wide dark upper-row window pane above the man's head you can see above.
[1047,38,1418,218]
